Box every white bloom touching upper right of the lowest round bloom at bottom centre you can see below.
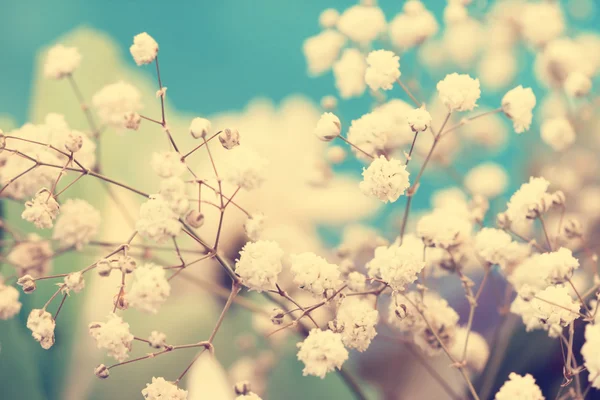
[336,297,379,352]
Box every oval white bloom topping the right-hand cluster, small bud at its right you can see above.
[506,176,552,221]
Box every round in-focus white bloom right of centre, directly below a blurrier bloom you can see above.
[359,156,410,203]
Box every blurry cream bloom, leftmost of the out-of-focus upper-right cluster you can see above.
[303,29,346,75]
